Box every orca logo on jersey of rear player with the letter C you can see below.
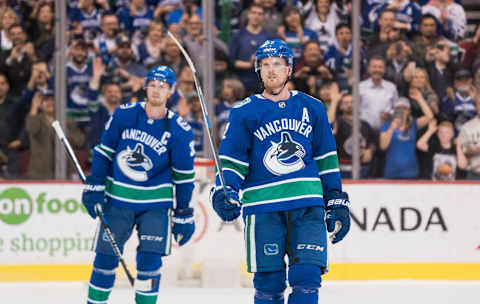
[117,143,153,182]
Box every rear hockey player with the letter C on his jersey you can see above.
[82,66,195,303]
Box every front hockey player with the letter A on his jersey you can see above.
[211,39,350,304]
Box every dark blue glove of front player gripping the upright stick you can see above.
[210,186,241,222]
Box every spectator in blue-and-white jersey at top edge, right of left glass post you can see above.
[68,0,103,42]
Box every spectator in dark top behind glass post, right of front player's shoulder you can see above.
[328,89,377,178]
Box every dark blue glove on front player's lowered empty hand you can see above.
[325,191,350,244]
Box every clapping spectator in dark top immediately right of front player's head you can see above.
[293,40,333,95]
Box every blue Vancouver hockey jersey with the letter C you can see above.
[92,102,195,210]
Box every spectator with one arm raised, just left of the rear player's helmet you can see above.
[88,57,122,149]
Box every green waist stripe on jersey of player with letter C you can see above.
[105,178,173,202]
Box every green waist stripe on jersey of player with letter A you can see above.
[242,178,323,206]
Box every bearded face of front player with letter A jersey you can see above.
[260,57,291,91]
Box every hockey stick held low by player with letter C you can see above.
[52,120,135,287]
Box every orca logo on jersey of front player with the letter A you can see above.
[263,132,305,175]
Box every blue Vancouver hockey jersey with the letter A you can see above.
[217,91,342,215]
